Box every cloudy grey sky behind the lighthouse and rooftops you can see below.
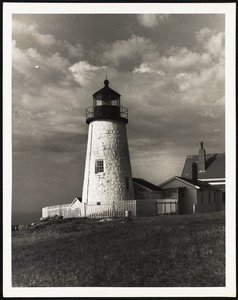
[12,14,225,224]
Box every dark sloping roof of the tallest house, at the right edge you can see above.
[181,153,225,179]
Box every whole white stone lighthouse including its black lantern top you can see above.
[82,79,134,205]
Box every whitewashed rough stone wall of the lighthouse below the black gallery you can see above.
[82,120,134,204]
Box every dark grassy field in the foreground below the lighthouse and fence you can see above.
[12,213,225,287]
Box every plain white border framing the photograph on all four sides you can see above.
[3,2,236,298]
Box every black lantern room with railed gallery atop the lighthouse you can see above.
[86,79,128,124]
